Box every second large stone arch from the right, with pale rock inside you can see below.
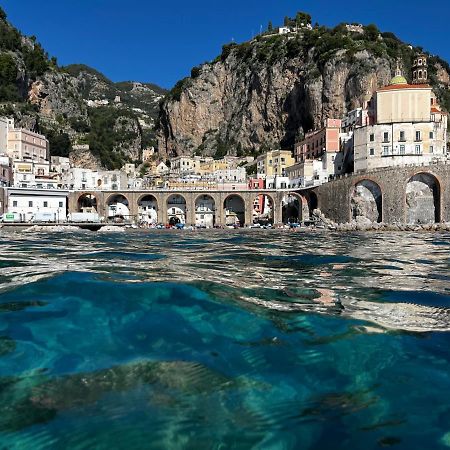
[350,179,383,223]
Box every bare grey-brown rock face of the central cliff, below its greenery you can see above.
[158,52,392,155]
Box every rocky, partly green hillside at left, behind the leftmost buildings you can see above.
[0,9,165,168]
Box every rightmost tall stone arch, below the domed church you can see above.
[405,172,441,224]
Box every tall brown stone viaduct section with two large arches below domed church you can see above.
[309,163,450,224]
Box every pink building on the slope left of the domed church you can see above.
[294,119,342,163]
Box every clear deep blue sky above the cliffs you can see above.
[1,0,450,88]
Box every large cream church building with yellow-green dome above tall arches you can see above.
[354,67,447,172]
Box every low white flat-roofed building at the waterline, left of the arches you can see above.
[5,188,69,222]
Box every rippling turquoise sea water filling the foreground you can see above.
[0,230,450,449]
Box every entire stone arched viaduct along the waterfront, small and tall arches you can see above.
[65,164,450,226]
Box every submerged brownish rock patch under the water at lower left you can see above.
[0,361,246,431]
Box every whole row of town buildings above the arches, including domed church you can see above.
[0,55,449,227]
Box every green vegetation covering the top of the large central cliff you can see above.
[167,12,450,116]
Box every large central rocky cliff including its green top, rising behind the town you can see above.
[158,20,450,156]
